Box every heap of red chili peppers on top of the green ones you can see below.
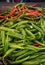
[0,4,45,18]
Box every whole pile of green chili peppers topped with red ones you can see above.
[0,3,45,65]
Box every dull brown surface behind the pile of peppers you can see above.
[0,2,45,12]
